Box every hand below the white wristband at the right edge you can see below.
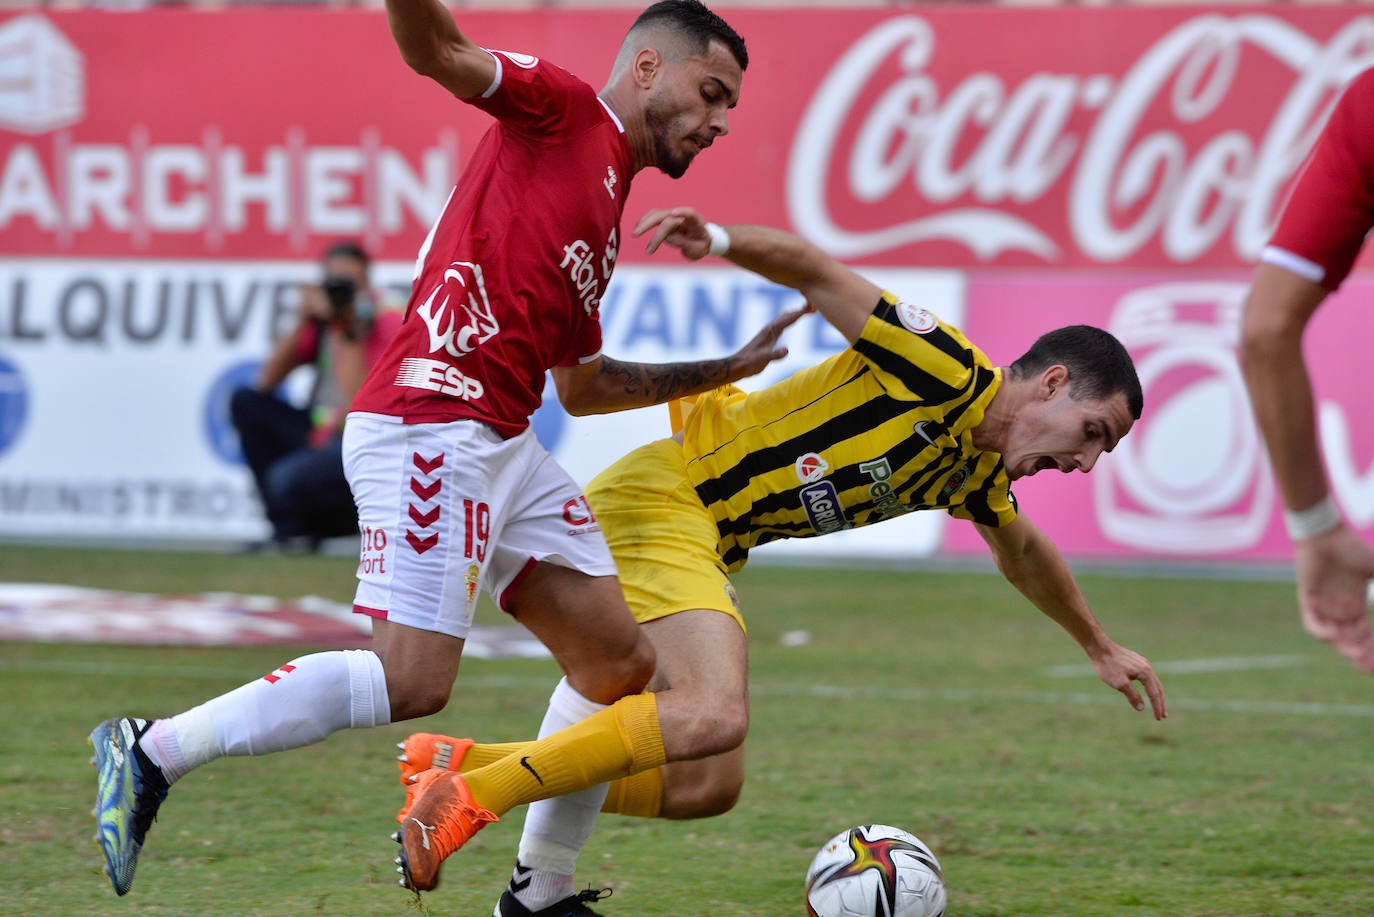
[1294,525,1374,672]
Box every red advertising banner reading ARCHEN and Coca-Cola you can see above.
[8,5,1374,268]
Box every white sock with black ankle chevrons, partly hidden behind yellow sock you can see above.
[511,678,609,910]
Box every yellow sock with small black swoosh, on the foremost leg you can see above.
[463,694,666,815]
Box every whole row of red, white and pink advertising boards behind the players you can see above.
[0,4,1374,562]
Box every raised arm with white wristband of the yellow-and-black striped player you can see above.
[635,208,882,344]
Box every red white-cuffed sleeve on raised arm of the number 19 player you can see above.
[466,49,602,135]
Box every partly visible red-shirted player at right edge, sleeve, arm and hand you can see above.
[1241,70,1374,672]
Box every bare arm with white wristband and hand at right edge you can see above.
[1241,264,1374,672]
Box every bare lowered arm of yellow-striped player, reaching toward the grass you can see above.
[977,516,1168,719]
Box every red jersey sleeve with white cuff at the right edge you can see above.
[1260,70,1374,290]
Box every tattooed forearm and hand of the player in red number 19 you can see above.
[552,307,811,417]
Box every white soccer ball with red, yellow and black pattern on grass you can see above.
[807,825,945,917]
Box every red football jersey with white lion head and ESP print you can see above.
[352,51,631,437]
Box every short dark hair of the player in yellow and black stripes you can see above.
[1011,324,1145,421]
